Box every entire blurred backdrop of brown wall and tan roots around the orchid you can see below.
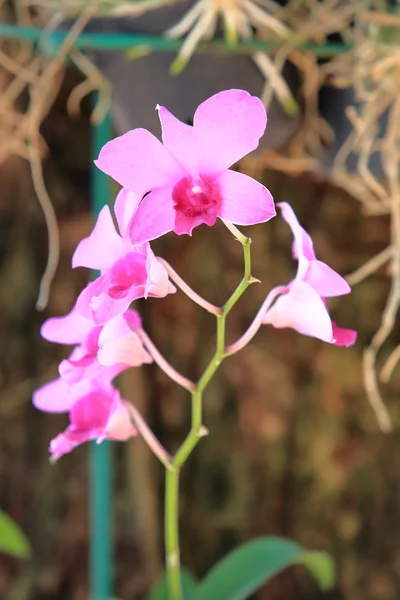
[0,0,400,600]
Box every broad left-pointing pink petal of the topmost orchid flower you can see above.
[95,129,185,196]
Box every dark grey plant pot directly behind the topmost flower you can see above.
[76,14,300,148]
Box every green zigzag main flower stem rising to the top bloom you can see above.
[165,224,253,600]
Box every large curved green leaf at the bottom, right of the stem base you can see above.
[194,537,334,600]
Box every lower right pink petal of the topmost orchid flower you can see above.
[217,171,276,225]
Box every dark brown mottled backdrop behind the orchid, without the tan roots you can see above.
[0,69,400,600]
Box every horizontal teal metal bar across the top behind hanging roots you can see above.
[0,23,352,56]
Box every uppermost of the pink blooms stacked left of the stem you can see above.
[72,197,176,324]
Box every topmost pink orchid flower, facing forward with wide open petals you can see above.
[96,90,275,244]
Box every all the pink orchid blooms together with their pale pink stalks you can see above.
[33,90,356,460]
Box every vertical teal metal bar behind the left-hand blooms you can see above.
[89,105,113,600]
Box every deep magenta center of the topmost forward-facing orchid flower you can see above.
[172,177,220,225]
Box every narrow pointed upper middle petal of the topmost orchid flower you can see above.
[158,106,199,176]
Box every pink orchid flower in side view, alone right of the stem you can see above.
[263,202,357,346]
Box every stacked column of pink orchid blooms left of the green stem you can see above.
[33,190,176,460]
